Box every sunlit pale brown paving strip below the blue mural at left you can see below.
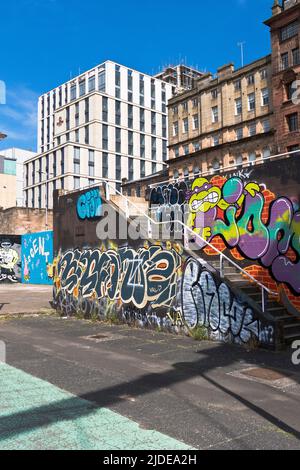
[0,284,52,315]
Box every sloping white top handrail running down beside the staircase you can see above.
[105,181,279,304]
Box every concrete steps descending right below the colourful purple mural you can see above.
[205,257,300,344]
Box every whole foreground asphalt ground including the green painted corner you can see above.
[0,316,300,450]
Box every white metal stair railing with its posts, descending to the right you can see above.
[104,182,279,313]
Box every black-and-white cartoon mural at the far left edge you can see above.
[0,235,21,283]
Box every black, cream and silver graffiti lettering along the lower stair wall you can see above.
[53,244,273,344]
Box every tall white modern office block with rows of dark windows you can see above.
[24,61,175,208]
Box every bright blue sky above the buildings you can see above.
[0,0,273,150]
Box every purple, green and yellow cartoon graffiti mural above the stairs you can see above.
[186,177,300,295]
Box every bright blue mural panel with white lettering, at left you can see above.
[21,232,53,285]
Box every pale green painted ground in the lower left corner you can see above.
[0,363,190,450]
